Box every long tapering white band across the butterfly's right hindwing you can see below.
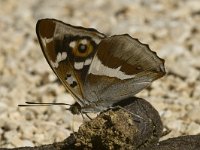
[89,56,134,80]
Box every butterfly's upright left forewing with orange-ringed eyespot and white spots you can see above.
[36,19,105,106]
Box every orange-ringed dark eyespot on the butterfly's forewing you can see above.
[72,39,93,57]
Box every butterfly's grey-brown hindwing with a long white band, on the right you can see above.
[84,34,165,111]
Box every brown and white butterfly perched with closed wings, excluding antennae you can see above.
[33,19,165,113]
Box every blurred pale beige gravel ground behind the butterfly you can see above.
[0,0,200,148]
